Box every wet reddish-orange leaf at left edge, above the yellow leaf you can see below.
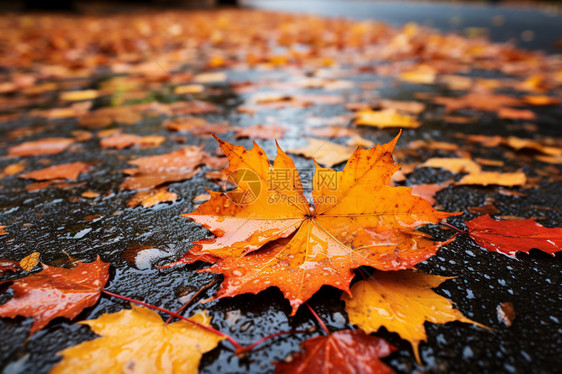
[0,257,109,335]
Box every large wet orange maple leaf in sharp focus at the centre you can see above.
[174,137,458,314]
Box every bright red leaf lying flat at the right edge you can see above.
[466,215,562,257]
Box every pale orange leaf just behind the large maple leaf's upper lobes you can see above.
[287,138,356,167]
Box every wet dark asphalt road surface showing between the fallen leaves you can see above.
[0,2,562,374]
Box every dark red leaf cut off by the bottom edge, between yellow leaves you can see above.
[275,330,396,374]
